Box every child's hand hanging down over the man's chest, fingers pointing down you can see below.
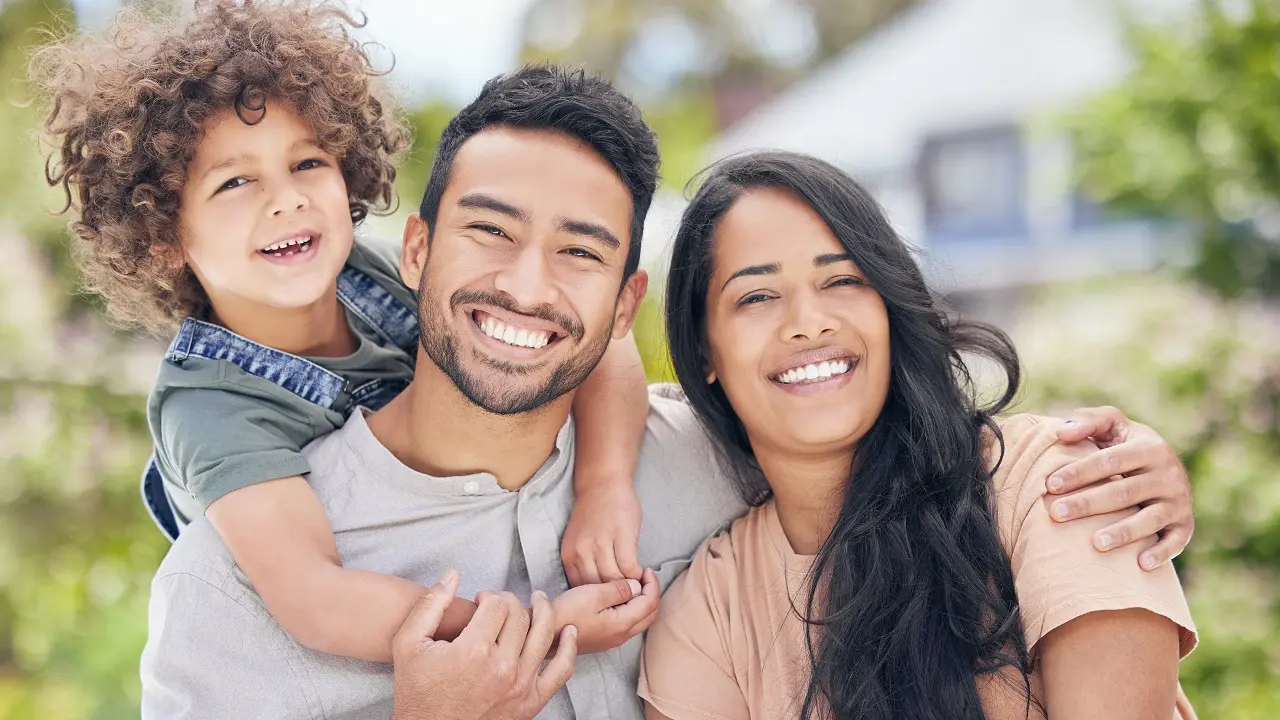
[561,483,644,584]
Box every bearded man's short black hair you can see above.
[419,64,658,278]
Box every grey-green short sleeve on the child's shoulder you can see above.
[155,386,317,509]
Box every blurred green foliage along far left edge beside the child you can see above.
[0,0,168,720]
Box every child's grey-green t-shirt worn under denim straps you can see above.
[147,241,417,528]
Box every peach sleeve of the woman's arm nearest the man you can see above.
[637,536,749,720]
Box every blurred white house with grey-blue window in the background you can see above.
[686,0,1187,304]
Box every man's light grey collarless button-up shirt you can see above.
[142,386,746,720]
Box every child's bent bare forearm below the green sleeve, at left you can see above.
[206,475,475,662]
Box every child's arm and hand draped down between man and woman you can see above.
[561,332,649,587]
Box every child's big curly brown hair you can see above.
[31,0,408,334]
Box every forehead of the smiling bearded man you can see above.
[440,127,632,229]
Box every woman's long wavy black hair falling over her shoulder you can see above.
[667,152,1030,720]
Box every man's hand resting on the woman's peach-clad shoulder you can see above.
[1048,407,1196,570]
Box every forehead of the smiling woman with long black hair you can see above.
[713,187,845,274]
